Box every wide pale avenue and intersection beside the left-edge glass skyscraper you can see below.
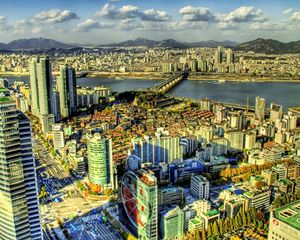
[33,135,107,227]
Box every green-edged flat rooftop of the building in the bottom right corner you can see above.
[273,200,300,231]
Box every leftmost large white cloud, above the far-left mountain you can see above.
[31,9,79,23]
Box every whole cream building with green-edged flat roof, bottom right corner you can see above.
[268,200,300,240]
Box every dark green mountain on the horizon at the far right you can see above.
[235,38,300,54]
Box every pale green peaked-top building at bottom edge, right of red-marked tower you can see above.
[160,206,184,239]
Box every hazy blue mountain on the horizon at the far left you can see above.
[0,38,74,50]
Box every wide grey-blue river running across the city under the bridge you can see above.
[7,76,300,108]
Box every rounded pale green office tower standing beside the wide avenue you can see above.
[87,133,114,189]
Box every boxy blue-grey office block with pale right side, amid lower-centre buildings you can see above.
[190,175,209,199]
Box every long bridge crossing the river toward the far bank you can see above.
[151,69,190,93]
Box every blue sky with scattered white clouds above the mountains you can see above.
[0,0,300,44]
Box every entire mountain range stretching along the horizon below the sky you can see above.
[0,38,300,53]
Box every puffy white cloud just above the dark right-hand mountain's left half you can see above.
[223,6,267,23]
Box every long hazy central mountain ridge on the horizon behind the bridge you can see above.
[99,38,238,48]
